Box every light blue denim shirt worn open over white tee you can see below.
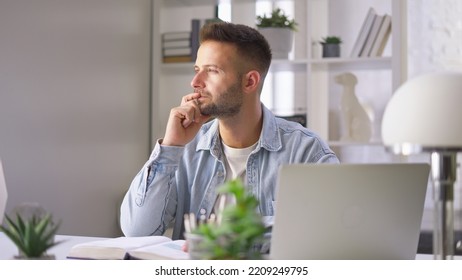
[120,105,339,239]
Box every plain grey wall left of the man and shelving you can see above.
[0,0,151,236]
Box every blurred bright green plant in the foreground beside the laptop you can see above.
[187,180,266,259]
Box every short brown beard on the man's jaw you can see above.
[200,79,244,118]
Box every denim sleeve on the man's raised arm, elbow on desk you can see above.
[120,141,183,236]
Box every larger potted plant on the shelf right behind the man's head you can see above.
[256,8,298,59]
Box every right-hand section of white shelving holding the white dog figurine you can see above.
[307,0,406,146]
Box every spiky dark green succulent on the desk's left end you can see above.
[0,214,60,259]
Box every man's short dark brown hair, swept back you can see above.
[200,21,272,78]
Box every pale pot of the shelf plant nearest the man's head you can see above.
[258,27,294,59]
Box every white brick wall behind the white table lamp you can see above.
[407,0,462,230]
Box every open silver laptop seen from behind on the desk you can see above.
[270,163,430,260]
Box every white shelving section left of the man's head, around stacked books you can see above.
[151,0,216,142]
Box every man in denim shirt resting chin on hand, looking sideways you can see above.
[121,22,338,239]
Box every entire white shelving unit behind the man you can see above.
[153,0,407,162]
